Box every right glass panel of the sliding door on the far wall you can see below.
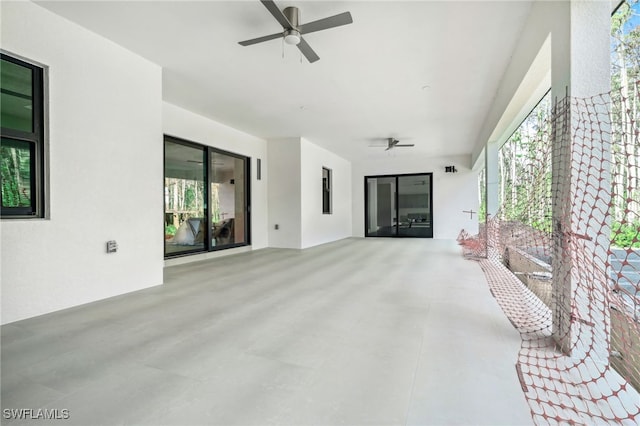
[398,174,433,238]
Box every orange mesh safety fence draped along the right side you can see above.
[458,81,640,425]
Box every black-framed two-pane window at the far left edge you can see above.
[0,53,44,219]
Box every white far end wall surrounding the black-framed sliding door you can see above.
[352,155,480,239]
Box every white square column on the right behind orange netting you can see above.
[551,0,611,363]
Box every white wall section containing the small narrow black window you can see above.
[301,139,352,248]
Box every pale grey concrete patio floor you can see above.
[2,239,532,425]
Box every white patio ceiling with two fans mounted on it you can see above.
[38,0,532,160]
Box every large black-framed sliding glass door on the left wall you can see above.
[164,136,250,257]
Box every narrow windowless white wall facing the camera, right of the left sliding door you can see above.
[263,138,302,249]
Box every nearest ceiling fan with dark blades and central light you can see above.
[239,0,353,62]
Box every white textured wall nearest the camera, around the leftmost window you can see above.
[0,2,163,323]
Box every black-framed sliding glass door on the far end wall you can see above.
[365,173,433,238]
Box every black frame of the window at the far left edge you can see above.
[0,51,47,219]
